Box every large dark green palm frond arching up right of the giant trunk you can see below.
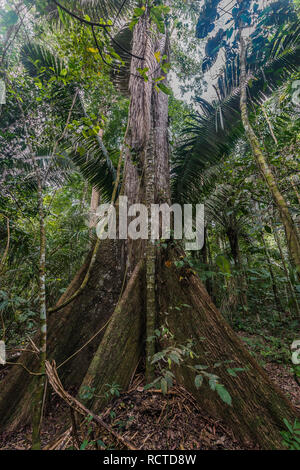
[171,26,300,202]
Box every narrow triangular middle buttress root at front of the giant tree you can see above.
[79,261,145,412]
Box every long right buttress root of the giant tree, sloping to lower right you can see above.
[159,246,299,449]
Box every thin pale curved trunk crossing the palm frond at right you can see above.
[240,35,300,279]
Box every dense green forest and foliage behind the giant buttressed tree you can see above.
[0,1,300,454]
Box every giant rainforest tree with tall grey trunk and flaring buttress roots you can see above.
[0,1,297,448]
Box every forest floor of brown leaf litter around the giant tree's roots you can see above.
[0,332,300,450]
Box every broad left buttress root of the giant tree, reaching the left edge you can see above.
[0,240,121,431]
